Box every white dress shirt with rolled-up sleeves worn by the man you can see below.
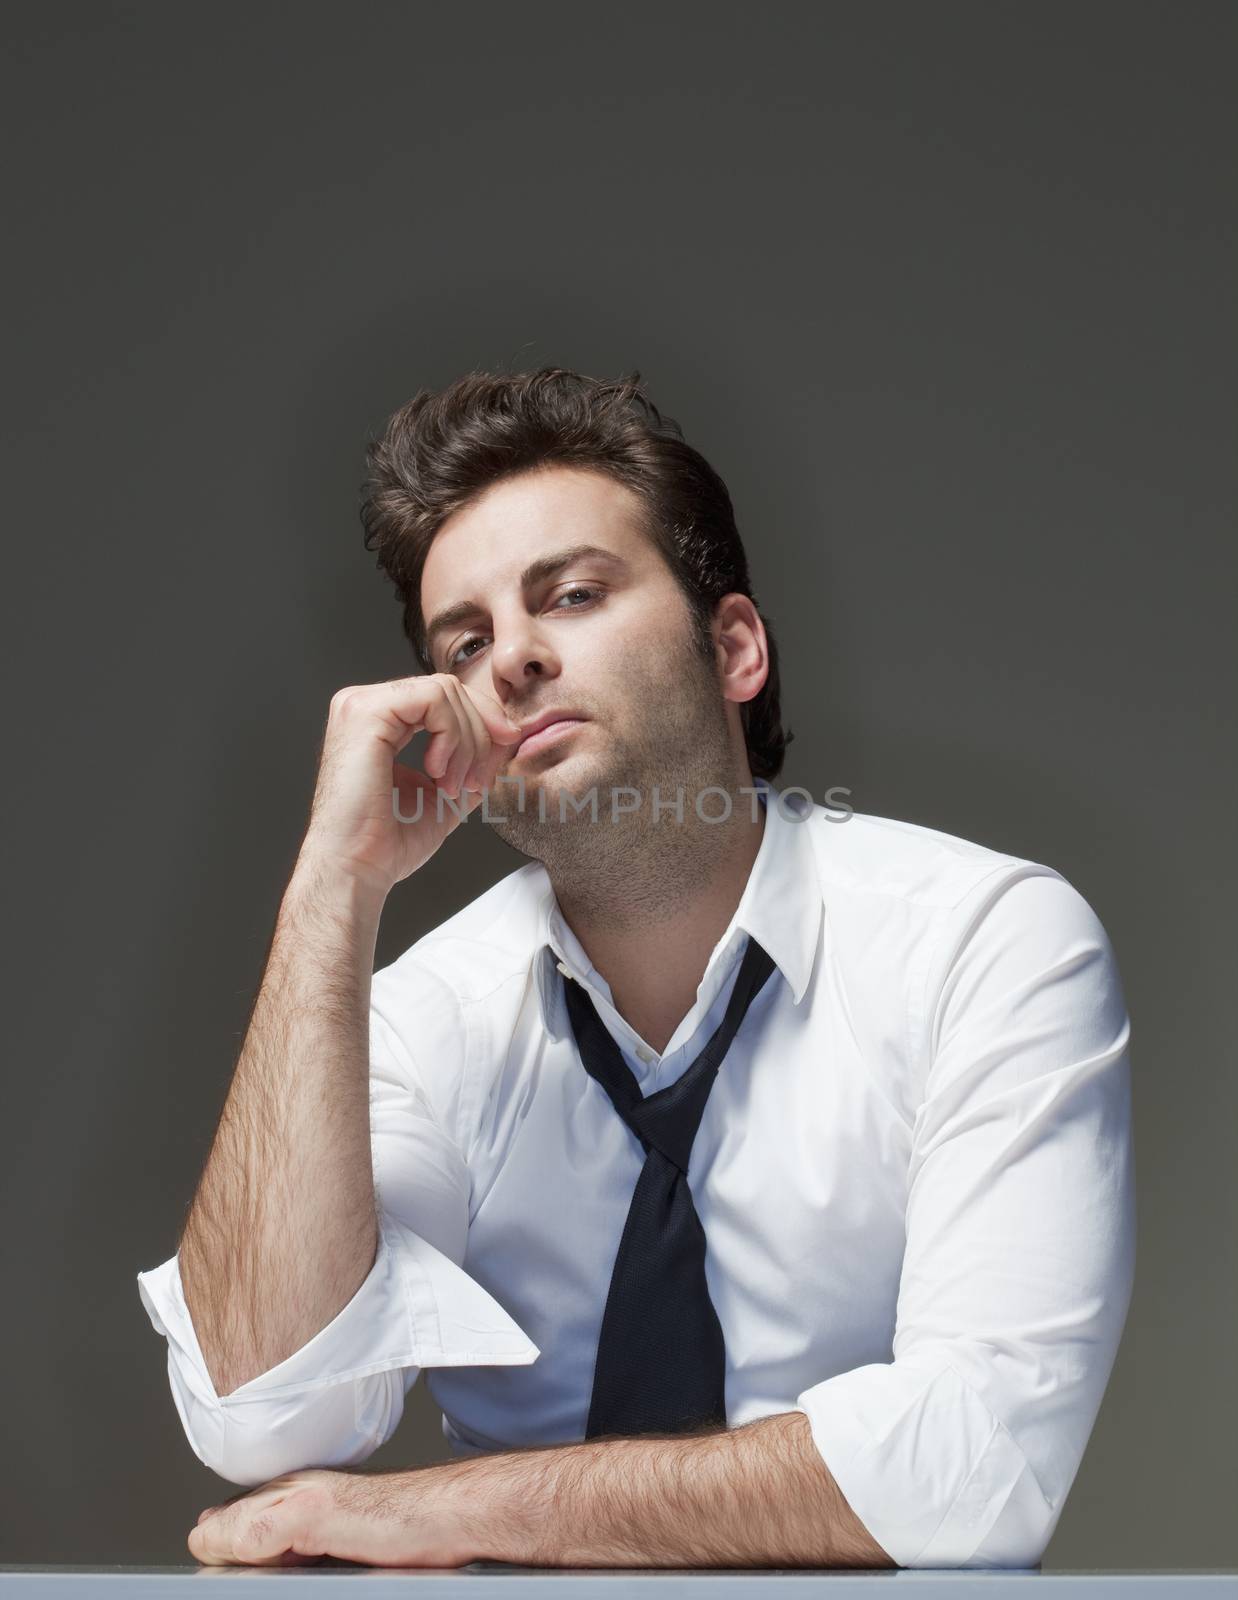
[138,781,1136,1566]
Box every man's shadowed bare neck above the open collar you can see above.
[547,778,765,1054]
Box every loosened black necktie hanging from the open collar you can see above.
[563,934,774,1438]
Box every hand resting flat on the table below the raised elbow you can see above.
[189,1467,475,1566]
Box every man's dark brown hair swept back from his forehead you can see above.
[361,366,795,779]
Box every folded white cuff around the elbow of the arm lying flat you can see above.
[793,1362,1056,1566]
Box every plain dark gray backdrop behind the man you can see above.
[0,0,1238,1568]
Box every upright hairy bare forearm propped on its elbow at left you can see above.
[179,858,382,1395]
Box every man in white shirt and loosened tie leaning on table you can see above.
[139,370,1134,1568]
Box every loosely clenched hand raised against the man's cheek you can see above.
[301,672,520,894]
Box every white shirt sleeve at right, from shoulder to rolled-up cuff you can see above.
[795,864,1136,1566]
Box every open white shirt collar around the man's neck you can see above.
[533,778,825,1038]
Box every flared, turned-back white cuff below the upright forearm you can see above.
[138,1216,541,1410]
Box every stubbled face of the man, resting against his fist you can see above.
[421,467,742,854]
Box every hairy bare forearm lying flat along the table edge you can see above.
[430,1411,896,1568]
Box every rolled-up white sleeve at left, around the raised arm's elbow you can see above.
[138,972,539,1486]
